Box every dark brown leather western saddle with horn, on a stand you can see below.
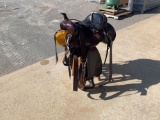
[54,12,116,90]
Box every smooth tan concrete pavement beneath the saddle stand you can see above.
[0,14,160,120]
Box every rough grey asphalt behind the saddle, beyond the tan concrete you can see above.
[0,0,160,77]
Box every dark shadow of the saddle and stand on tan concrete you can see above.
[86,59,160,100]
